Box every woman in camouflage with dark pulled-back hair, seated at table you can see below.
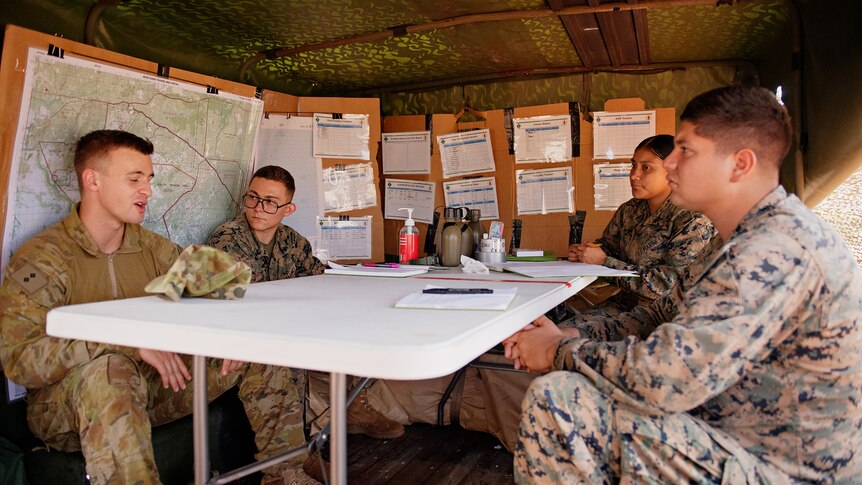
[569,135,715,317]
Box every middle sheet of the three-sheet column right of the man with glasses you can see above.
[321,163,377,212]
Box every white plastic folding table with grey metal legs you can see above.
[47,271,595,484]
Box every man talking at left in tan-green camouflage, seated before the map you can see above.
[0,130,313,484]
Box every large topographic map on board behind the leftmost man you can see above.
[2,49,263,266]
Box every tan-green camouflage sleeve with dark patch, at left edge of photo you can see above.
[0,258,95,388]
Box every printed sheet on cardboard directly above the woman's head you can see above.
[593,110,655,160]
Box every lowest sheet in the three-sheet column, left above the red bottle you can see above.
[317,216,371,260]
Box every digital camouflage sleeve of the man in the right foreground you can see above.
[555,234,823,412]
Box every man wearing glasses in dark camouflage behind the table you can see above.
[207,165,324,283]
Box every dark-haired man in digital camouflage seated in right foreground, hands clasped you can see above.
[506,86,862,483]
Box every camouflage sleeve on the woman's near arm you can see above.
[604,214,715,300]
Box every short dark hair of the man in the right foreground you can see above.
[680,85,793,169]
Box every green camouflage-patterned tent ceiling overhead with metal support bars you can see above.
[0,0,791,96]
